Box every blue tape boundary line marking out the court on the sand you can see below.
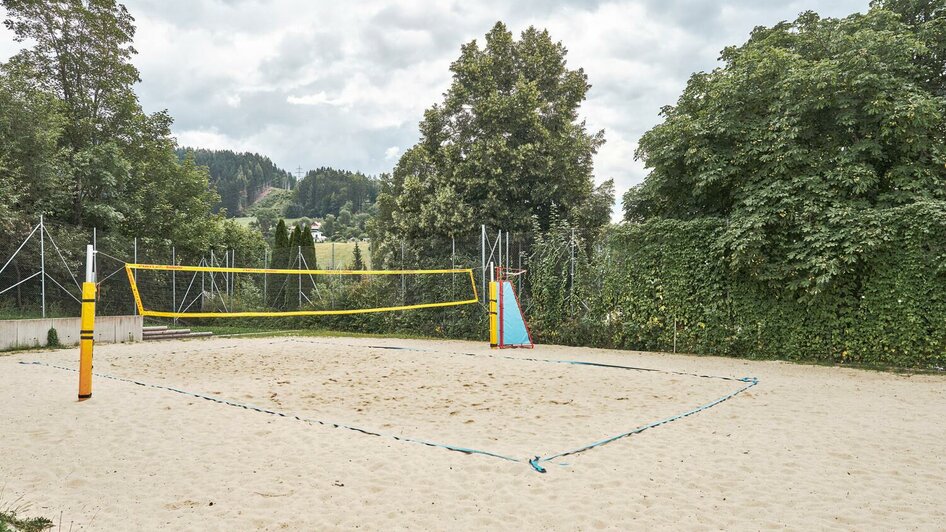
[20,340,759,473]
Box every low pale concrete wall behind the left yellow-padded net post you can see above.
[0,316,143,350]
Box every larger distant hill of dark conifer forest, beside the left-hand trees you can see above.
[177,148,295,216]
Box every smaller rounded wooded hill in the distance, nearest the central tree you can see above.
[294,167,378,218]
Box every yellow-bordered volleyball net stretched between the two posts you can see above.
[125,264,479,318]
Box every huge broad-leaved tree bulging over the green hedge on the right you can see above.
[624,2,946,294]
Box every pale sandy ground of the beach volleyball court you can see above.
[0,338,946,530]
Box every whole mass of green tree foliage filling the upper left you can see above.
[0,0,218,258]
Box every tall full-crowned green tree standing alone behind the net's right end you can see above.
[375,22,604,245]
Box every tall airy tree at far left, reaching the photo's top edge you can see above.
[4,0,141,223]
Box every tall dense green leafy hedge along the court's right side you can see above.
[531,203,946,368]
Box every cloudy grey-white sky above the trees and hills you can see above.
[0,0,868,216]
